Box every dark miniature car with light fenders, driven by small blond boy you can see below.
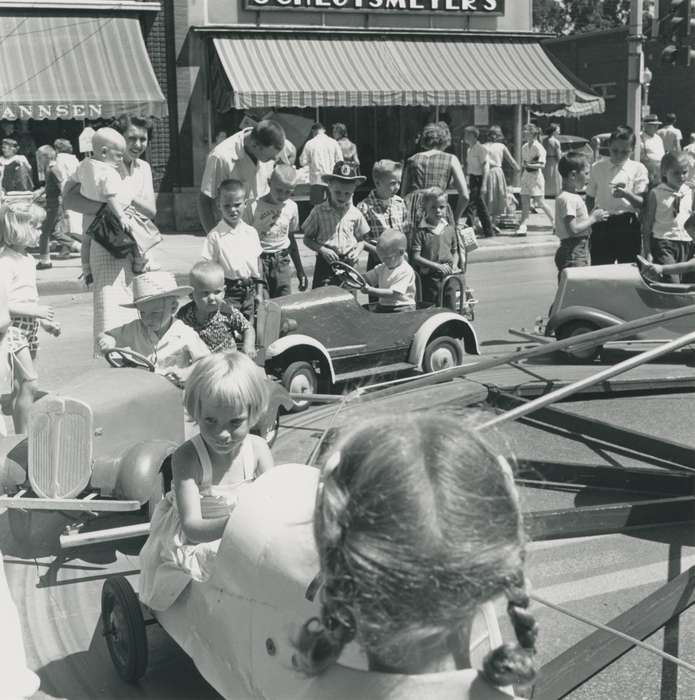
[256,263,480,407]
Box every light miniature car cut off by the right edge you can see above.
[545,264,695,361]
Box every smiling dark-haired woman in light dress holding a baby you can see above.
[63,114,157,357]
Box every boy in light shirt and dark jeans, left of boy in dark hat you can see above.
[243,164,307,298]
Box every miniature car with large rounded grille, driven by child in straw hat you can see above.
[0,348,292,544]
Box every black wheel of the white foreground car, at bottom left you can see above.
[101,576,147,683]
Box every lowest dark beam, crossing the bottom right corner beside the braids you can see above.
[533,568,695,700]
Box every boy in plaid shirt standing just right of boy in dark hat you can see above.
[357,160,410,270]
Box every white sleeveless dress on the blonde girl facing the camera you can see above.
[139,434,256,610]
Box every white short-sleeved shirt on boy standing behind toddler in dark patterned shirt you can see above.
[200,221,263,280]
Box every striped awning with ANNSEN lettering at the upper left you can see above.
[0,14,166,119]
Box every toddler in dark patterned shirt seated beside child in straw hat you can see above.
[177,262,256,359]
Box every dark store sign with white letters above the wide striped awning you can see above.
[245,0,505,15]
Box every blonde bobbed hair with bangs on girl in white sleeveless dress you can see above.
[183,350,269,426]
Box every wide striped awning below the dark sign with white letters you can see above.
[214,34,575,110]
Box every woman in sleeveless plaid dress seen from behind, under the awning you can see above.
[401,122,469,231]
